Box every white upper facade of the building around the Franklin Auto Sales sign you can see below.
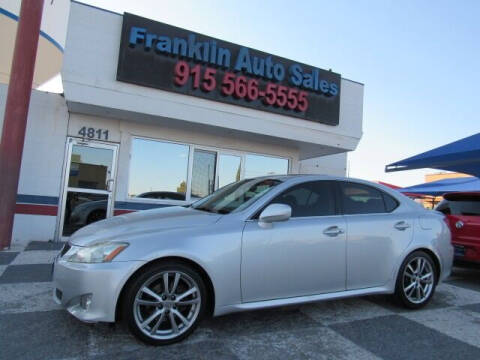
[62,2,363,160]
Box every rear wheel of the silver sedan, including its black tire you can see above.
[394,251,437,309]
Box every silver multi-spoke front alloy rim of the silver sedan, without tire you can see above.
[133,271,202,340]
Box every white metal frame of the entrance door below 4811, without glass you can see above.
[55,137,119,241]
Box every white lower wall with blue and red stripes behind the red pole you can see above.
[0,84,68,243]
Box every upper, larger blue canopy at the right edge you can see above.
[385,133,480,177]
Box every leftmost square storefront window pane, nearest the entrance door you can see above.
[128,138,189,200]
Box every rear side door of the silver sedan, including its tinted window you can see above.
[340,181,414,290]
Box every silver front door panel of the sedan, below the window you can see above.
[241,216,346,302]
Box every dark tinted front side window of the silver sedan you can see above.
[271,181,335,217]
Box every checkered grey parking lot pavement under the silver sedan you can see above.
[0,242,480,360]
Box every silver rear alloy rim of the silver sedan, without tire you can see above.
[402,257,434,304]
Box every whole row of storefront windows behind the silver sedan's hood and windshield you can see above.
[128,138,289,201]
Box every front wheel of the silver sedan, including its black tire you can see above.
[122,261,209,345]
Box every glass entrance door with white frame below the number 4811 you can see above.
[59,138,117,237]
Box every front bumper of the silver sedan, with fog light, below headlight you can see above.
[53,258,139,322]
